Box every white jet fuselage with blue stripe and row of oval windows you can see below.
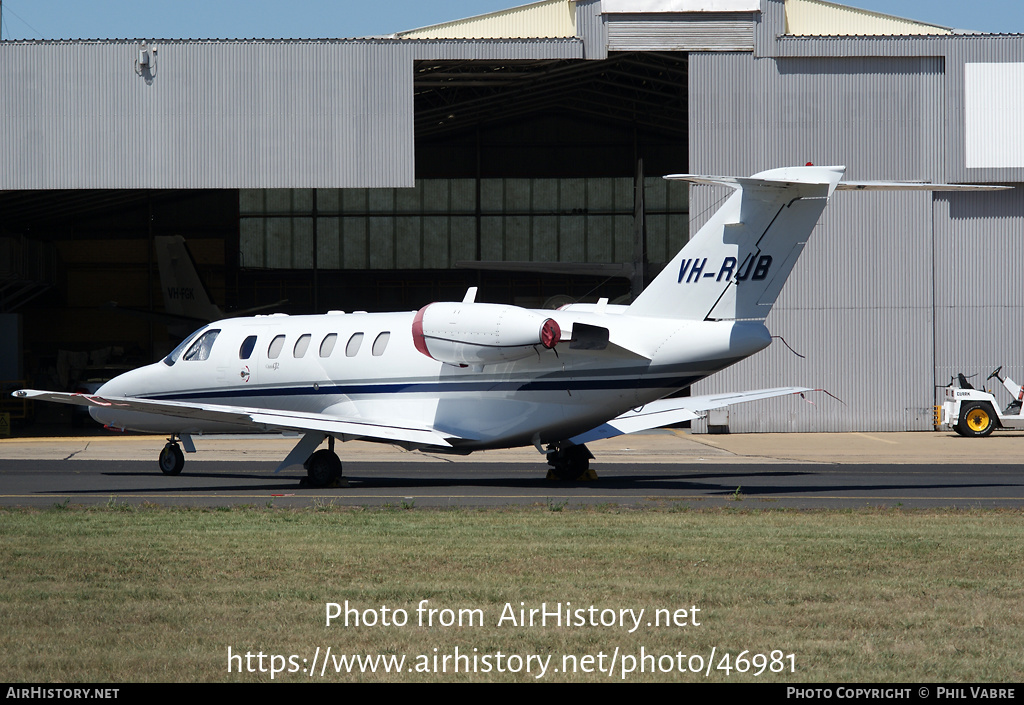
[90,307,770,451]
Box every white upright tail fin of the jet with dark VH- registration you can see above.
[629,166,846,321]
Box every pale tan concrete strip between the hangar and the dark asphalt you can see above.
[0,429,1024,465]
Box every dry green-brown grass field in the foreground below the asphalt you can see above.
[0,504,1024,682]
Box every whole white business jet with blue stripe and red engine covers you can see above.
[14,166,997,486]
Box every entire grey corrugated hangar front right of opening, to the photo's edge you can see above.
[690,5,1024,431]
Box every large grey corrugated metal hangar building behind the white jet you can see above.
[0,0,1024,431]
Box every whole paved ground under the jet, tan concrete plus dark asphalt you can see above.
[0,430,1024,509]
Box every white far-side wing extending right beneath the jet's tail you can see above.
[569,386,813,446]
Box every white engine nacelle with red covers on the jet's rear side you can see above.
[413,302,562,365]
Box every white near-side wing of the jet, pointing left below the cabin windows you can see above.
[14,389,454,448]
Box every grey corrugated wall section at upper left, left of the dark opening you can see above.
[0,41,414,189]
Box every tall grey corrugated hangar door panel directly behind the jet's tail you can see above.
[690,53,958,431]
